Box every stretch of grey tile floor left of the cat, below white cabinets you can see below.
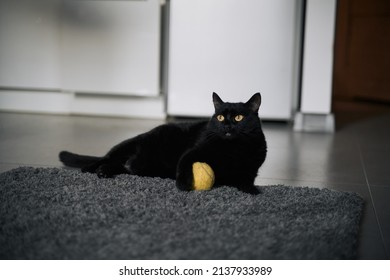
[0,113,162,166]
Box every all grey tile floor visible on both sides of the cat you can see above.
[0,110,390,259]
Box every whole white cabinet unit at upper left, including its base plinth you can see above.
[0,0,165,118]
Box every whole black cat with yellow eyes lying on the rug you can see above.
[59,93,267,193]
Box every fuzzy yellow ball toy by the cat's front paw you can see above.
[192,162,215,191]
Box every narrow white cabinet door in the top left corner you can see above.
[0,0,61,90]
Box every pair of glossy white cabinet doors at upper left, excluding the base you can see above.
[0,0,161,96]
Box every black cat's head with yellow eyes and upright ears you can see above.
[209,92,261,139]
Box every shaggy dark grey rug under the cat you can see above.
[0,167,363,259]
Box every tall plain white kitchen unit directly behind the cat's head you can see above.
[167,0,302,120]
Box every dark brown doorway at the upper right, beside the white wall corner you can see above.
[333,0,390,127]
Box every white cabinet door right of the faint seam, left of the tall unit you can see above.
[61,0,160,96]
